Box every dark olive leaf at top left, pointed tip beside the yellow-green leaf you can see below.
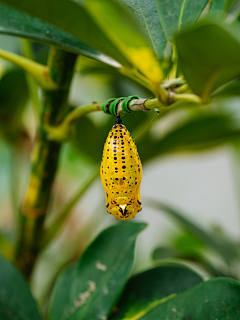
[1,0,129,65]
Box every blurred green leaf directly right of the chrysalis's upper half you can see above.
[137,111,240,162]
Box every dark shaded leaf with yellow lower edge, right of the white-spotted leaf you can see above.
[110,265,202,320]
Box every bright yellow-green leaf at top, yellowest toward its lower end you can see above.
[83,0,164,87]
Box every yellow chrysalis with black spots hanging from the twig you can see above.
[100,119,142,220]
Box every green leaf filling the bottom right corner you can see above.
[138,278,240,320]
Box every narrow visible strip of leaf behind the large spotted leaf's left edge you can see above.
[48,264,77,320]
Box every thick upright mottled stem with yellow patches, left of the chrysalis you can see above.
[15,48,77,278]
